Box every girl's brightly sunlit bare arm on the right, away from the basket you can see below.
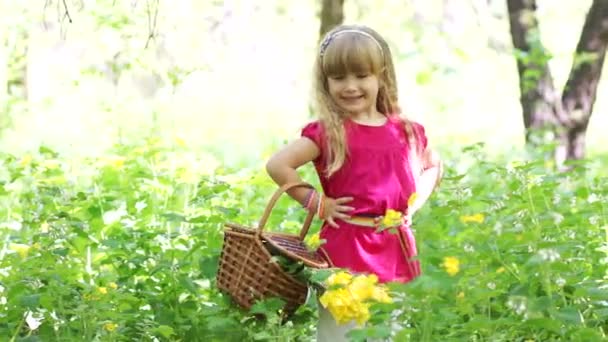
[407,148,443,217]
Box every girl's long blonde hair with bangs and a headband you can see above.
[314,25,422,177]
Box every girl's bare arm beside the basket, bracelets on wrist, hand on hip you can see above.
[266,137,353,227]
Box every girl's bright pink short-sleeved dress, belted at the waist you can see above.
[302,116,427,282]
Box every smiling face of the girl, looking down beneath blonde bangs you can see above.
[327,71,379,116]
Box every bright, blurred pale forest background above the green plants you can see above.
[0,0,608,165]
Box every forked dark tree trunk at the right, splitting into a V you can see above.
[507,0,608,165]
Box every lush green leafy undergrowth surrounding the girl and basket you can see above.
[0,140,608,341]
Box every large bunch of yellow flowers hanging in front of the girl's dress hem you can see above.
[319,271,392,325]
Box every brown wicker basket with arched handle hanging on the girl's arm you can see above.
[217,183,327,312]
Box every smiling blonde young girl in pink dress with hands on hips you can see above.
[266,25,441,341]
